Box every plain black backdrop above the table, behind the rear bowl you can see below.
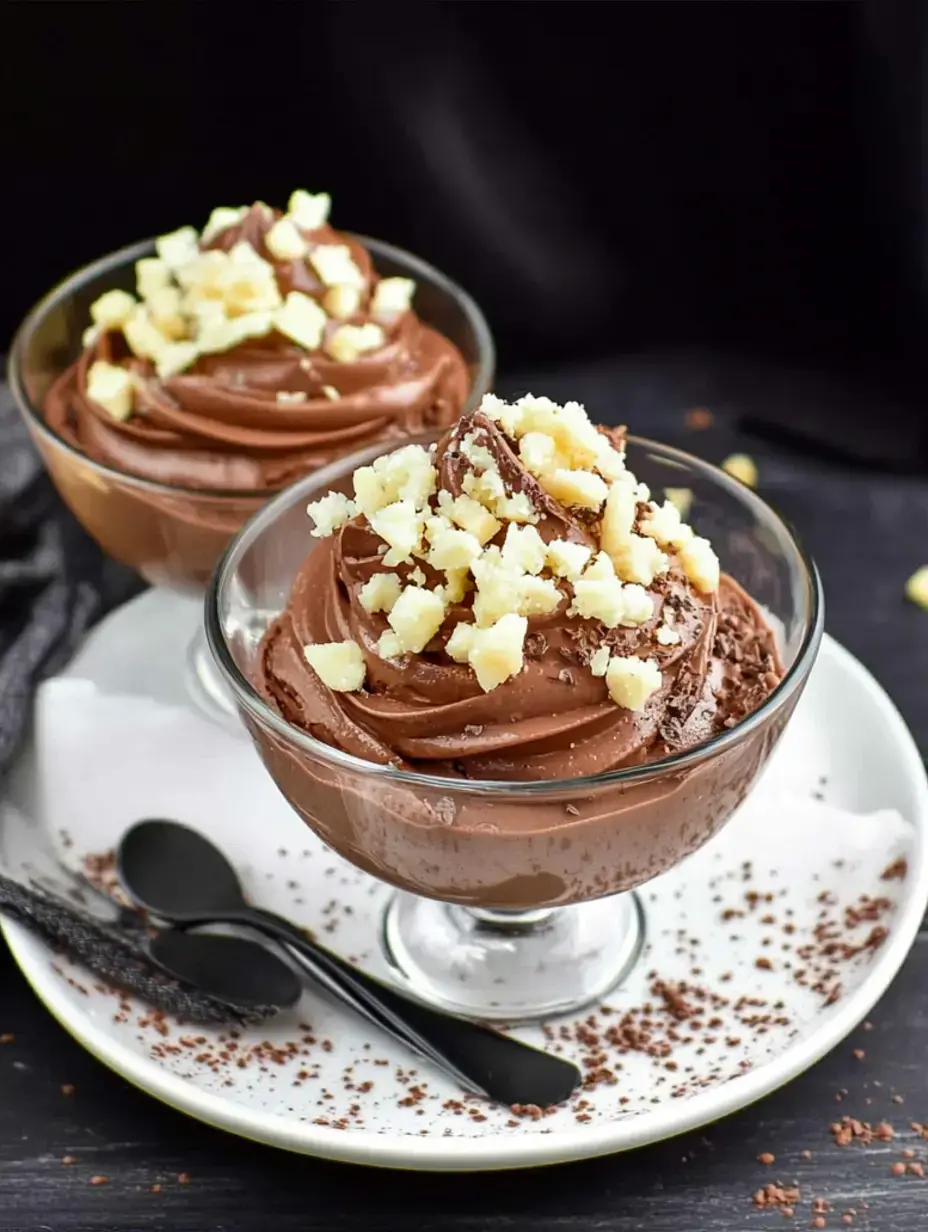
[0,0,928,413]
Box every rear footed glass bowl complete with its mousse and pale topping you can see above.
[9,193,494,717]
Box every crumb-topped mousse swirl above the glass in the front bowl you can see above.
[259,394,781,778]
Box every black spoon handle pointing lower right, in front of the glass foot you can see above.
[242,908,582,1108]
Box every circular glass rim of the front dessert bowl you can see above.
[205,434,824,797]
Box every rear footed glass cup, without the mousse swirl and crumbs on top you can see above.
[9,235,494,726]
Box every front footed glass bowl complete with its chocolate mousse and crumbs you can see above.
[207,395,823,1021]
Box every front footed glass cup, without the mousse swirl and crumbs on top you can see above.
[206,437,823,1021]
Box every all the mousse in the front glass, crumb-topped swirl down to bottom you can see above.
[250,395,799,908]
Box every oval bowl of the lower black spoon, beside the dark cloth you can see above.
[148,928,303,1009]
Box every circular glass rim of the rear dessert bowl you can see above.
[6,230,497,501]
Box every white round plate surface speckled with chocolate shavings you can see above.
[0,591,928,1169]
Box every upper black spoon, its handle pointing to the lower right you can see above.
[117,821,582,1108]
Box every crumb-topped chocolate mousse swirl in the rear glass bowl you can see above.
[43,191,470,492]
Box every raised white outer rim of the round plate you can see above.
[0,633,928,1172]
